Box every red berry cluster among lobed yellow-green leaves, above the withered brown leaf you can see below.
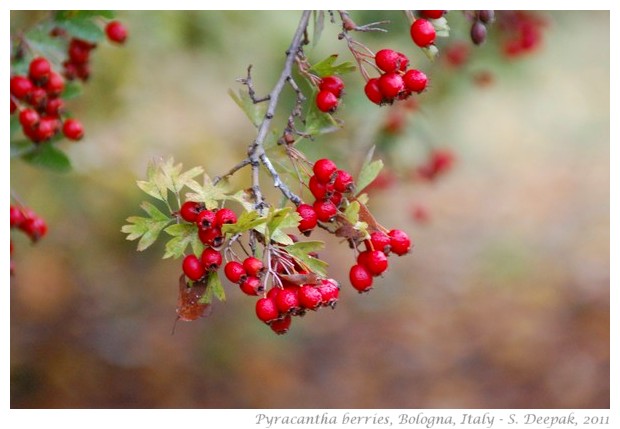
[179,201,237,282]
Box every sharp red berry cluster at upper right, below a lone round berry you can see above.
[364,49,428,104]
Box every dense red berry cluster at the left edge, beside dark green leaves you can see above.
[11,57,84,143]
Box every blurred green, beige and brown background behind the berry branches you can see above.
[11,11,610,408]
